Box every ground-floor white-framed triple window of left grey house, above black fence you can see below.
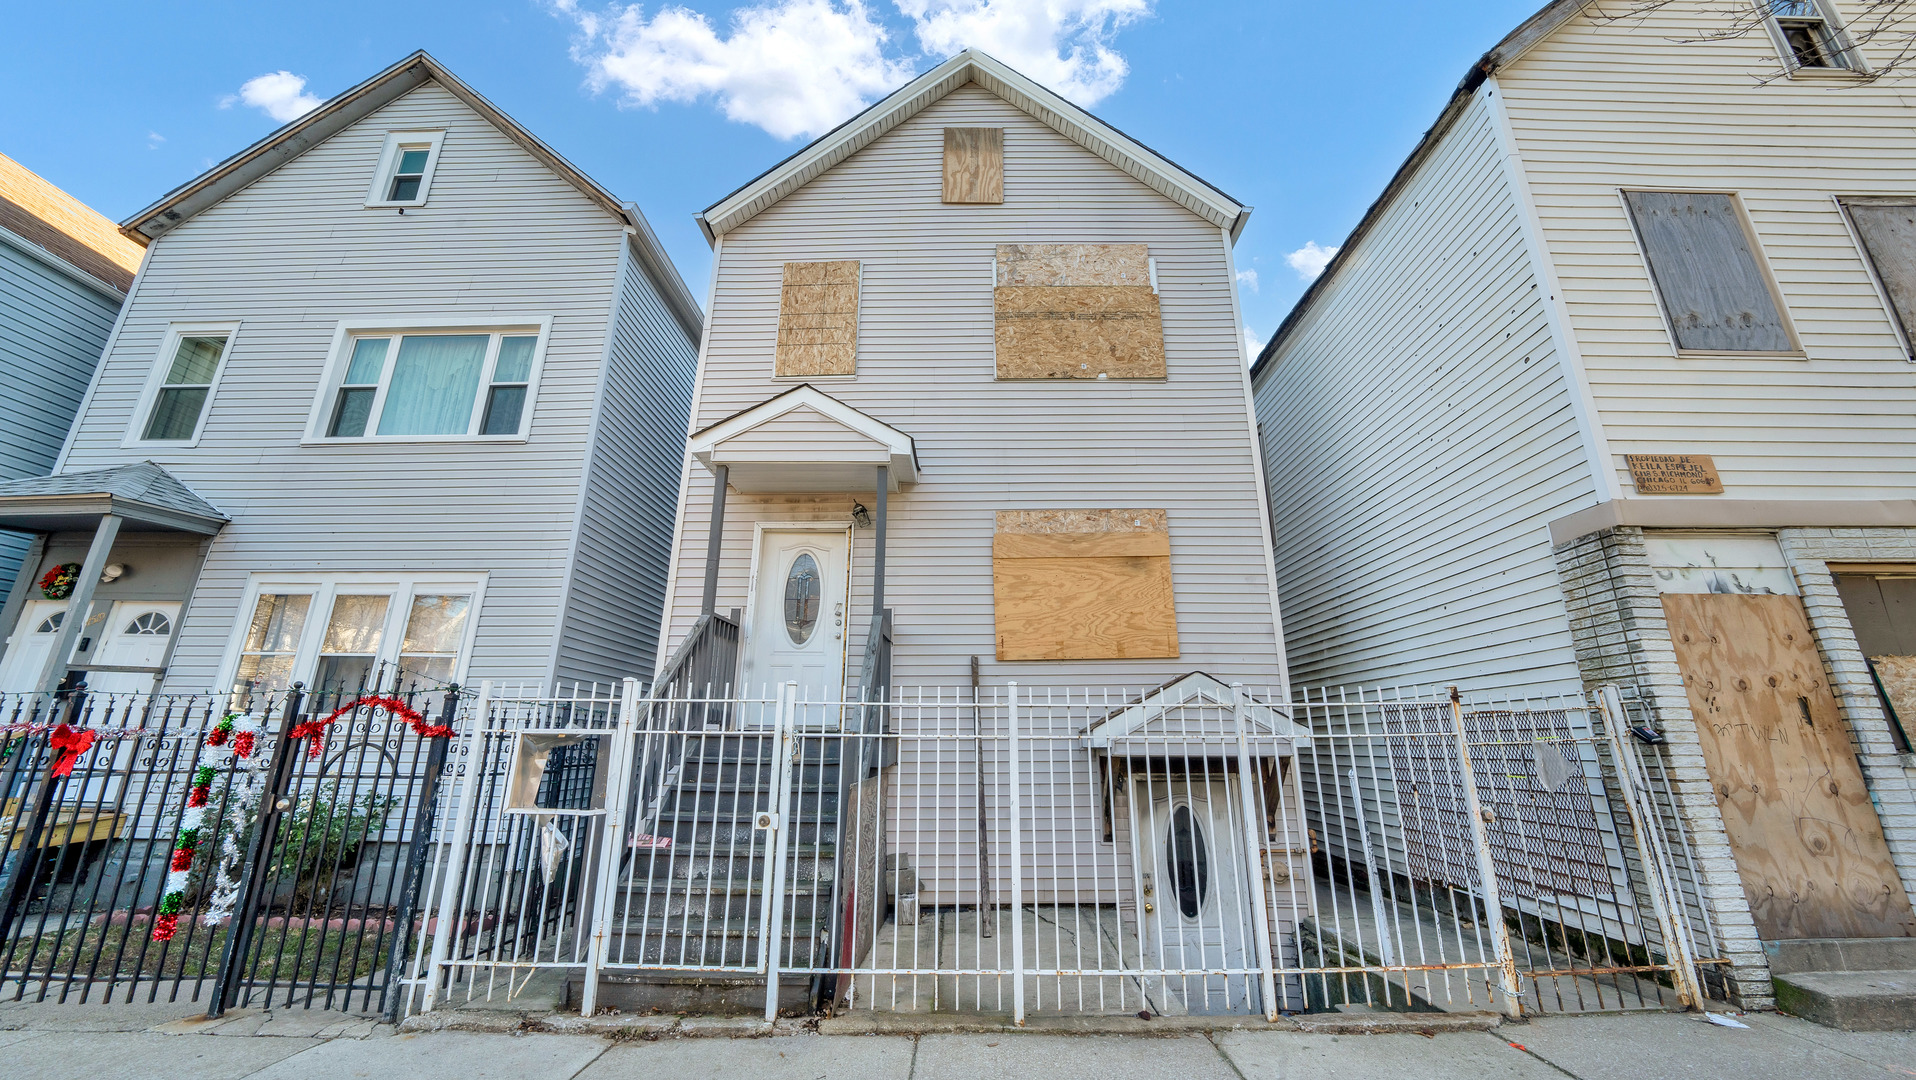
[222,573,485,703]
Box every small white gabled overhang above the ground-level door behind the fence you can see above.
[1083,672,1311,758]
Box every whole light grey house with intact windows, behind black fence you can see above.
[0,52,701,693]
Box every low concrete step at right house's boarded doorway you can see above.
[1763,938,1916,1032]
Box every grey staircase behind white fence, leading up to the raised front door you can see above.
[567,731,839,1013]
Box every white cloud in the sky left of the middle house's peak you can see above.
[554,0,912,138]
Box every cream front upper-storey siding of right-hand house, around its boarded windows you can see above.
[1498,2,1916,500]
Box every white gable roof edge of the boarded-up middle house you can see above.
[697,48,1251,241]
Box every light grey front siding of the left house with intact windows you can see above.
[63,82,625,689]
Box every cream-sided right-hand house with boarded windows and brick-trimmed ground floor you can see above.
[1253,0,1916,1003]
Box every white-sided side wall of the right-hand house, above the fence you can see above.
[1255,84,1596,689]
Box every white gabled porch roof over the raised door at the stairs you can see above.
[690,383,918,494]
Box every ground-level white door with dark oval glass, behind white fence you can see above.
[1136,774,1261,1013]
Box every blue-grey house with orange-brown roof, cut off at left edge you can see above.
[0,155,144,616]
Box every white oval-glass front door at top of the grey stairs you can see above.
[740,527,851,712]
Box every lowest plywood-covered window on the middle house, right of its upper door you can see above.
[991,509,1178,661]
